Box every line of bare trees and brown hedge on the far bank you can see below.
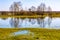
[9,2,52,15]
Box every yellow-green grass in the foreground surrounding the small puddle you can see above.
[0,28,60,40]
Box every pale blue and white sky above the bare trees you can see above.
[0,0,60,11]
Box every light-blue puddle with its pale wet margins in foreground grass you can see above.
[9,30,34,37]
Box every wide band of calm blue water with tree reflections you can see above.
[0,17,60,28]
